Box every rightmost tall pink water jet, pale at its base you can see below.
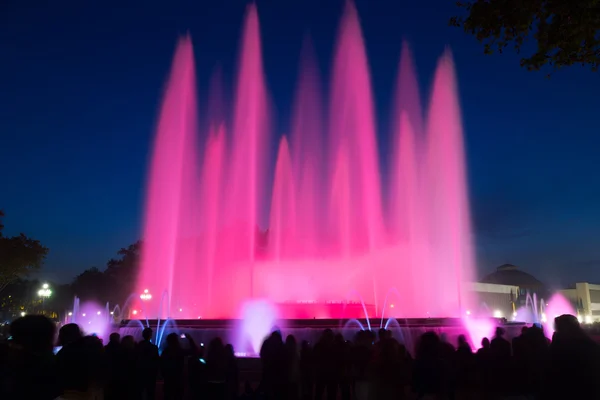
[426,50,474,315]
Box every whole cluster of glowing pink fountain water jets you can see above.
[137,2,474,320]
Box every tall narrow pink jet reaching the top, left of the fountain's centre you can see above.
[220,5,269,313]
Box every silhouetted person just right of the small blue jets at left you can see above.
[160,333,185,400]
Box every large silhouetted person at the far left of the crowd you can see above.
[0,315,59,400]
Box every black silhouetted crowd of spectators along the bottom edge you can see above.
[0,315,600,400]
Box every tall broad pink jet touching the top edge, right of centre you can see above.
[329,2,383,262]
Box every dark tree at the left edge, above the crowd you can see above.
[0,212,49,292]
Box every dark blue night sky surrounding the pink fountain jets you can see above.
[0,0,600,288]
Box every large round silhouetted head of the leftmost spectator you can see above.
[10,315,55,353]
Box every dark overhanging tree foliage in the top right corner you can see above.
[450,0,600,71]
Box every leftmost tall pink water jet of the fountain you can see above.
[137,36,197,318]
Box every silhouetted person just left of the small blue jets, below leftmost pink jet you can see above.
[137,328,159,400]
